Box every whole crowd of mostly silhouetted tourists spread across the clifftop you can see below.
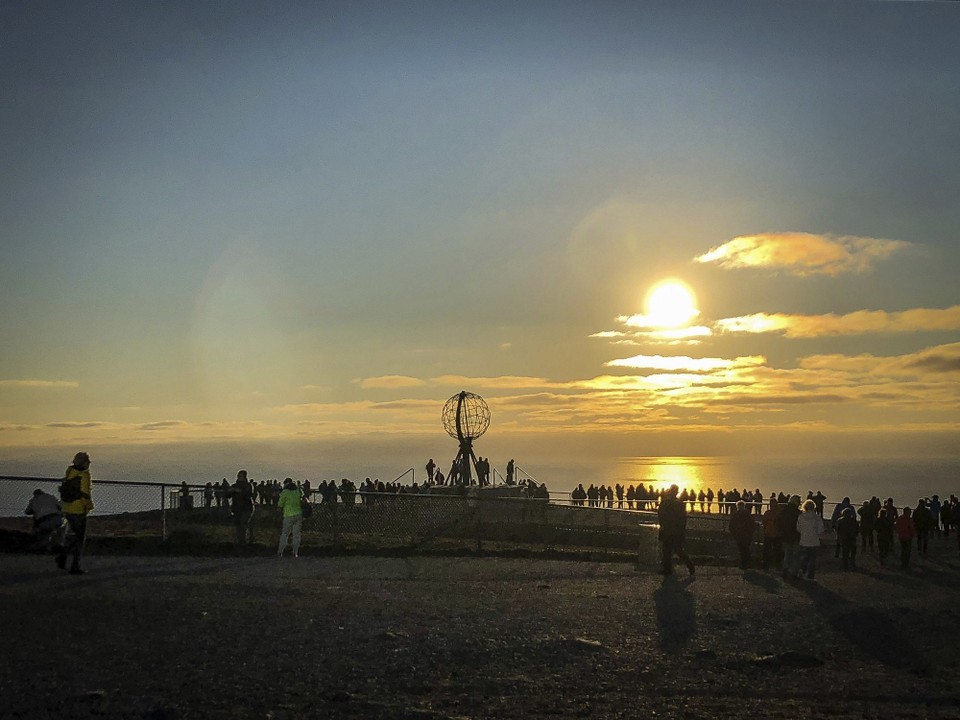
[20,452,960,579]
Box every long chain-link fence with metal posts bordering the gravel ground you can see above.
[0,476,762,568]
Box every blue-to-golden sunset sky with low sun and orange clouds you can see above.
[0,0,960,484]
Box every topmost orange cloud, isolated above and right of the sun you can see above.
[694,232,910,276]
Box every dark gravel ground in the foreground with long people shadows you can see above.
[0,537,960,720]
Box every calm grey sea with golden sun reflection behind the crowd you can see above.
[0,456,960,516]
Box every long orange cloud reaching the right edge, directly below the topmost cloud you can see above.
[716,305,960,338]
